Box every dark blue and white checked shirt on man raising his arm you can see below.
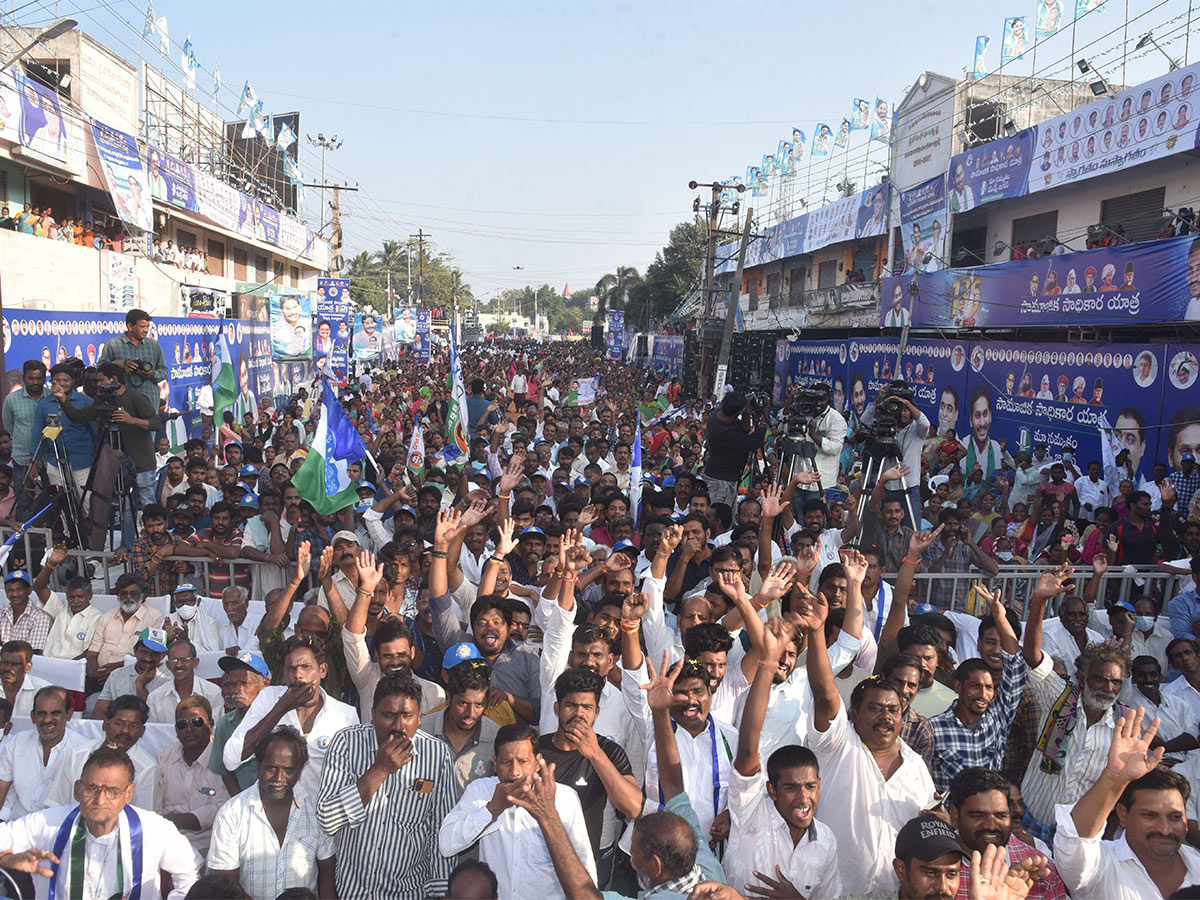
[929,653,1026,793]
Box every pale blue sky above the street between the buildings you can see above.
[60,0,1188,296]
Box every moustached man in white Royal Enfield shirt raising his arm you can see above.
[806,553,936,894]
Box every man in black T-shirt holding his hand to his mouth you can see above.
[536,668,642,884]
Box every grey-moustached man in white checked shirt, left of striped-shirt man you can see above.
[208,725,336,900]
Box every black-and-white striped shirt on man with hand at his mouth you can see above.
[317,724,455,900]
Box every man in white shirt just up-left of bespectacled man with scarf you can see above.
[0,685,83,822]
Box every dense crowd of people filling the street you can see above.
[0,331,1200,900]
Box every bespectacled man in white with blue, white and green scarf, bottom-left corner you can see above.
[0,748,199,900]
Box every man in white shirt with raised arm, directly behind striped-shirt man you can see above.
[342,550,445,719]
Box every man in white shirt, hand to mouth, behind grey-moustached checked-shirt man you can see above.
[223,636,359,797]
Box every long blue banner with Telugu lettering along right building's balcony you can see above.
[881,235,1200,328]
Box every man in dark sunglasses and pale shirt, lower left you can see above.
[155,695,229,857]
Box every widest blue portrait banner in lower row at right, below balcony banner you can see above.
[959,341,1165,479]
